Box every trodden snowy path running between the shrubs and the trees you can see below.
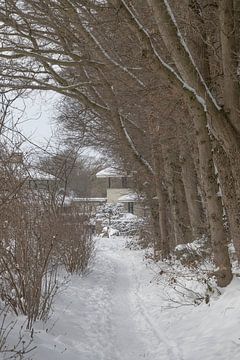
[34,237,182,360]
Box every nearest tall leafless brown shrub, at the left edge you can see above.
[0,150,58,328]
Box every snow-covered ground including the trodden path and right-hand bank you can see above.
[4,237,240,360]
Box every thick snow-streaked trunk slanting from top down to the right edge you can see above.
[148,0,240,156]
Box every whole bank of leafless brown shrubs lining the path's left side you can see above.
[0,96,94,329]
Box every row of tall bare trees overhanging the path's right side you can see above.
[0,0,240,286]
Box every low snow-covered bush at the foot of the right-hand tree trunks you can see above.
[142,237,220,307]
